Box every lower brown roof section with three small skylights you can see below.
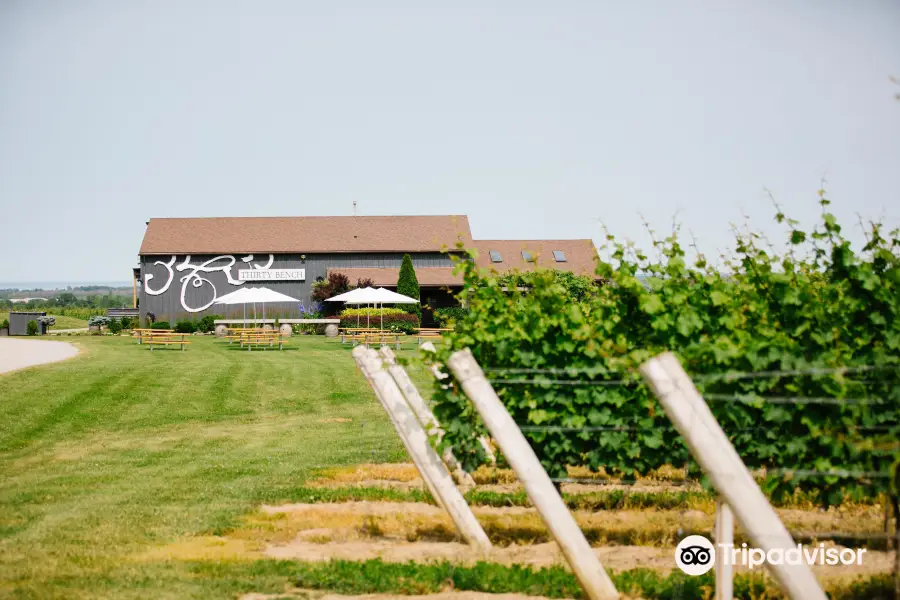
[474,240,597,277]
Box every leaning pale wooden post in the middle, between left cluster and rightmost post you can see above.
[447,349,619,600]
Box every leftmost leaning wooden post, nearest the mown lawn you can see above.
[353,345,491,550]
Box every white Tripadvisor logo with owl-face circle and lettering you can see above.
[675,535,866,575]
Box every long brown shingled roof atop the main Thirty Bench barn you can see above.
[140,215,472,254]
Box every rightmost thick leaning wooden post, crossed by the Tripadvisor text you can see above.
[640,352,826,600]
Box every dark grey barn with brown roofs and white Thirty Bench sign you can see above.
[134,215,597,322]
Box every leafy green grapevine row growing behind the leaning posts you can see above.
[434,198,900,504]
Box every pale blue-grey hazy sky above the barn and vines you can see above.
[0,0,900,281]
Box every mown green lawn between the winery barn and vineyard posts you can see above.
[0,336,414,598]
